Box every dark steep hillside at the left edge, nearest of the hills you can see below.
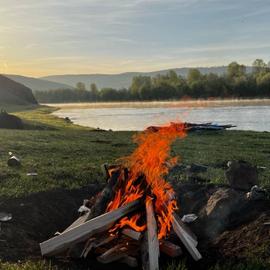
[0,75,37,105]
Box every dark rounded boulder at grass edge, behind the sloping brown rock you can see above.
[225,161,258,190]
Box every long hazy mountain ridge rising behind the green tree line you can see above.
[41,66,251,89]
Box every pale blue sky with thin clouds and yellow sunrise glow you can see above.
[0,0,270,77]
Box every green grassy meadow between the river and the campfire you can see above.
[0,104,270,196]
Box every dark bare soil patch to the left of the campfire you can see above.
[0,185,101,261]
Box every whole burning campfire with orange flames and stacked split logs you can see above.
[40,123,201,270]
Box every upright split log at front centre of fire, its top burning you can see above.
[146,198,159,270]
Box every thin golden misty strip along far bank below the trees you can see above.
[43,99,270,109]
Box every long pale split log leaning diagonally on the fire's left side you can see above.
[40,200,140,256]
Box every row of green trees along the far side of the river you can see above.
[35,59,270,103]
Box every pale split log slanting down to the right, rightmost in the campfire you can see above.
[172,214,202,261]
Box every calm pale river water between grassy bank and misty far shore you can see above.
[54,106,270,131]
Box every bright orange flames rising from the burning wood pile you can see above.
[107,123,186,239]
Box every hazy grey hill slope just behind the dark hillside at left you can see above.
[5,74,73,92]
